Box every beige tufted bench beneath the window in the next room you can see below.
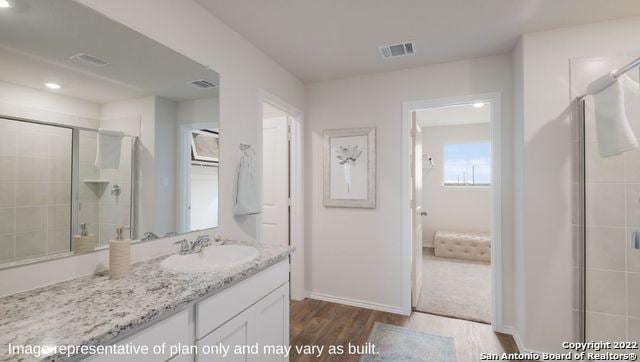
[434,231,491,262]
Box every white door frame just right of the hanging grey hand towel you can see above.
[256,89,306,300]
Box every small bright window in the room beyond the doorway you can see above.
[443,142,491,186]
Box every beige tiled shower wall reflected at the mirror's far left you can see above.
[0,119,72,262]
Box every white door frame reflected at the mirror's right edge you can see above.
[177,122,220,233]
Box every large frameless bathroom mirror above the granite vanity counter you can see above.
[0,0,220,267]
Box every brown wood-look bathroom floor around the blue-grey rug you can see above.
[290,299,517,362]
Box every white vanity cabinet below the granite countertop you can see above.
[92,260,289,362]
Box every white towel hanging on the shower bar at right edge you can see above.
[585,75,640,157]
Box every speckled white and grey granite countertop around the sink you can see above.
[0,242,292,361]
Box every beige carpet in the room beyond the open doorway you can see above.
[416,248,491,323]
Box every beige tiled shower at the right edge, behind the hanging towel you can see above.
[571,51,640,344]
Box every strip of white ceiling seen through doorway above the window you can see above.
[416,104,491,128]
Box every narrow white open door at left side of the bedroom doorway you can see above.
[410,112,423,307]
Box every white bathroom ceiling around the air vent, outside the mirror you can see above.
[198,0,640,82]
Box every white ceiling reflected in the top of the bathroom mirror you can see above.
[0,0,219,103]
